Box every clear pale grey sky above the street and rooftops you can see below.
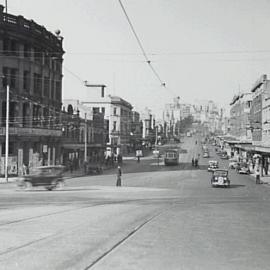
[4,0,270,116]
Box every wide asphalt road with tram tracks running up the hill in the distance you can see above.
[0,138,270,270]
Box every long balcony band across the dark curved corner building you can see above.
[0,127,62,137]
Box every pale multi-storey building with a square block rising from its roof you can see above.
[78,85,133,154]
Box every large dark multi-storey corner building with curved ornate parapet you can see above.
[0,5,64,175]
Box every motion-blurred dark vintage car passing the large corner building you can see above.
[17,165,65,190]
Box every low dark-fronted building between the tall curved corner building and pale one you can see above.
[61,99,107,166]
